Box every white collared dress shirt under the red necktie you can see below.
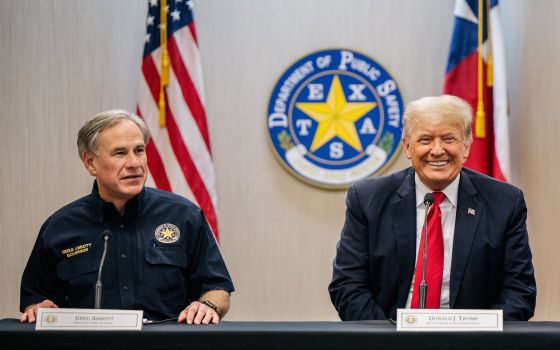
[406,174,461,309]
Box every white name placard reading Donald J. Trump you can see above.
[397,309,504,332]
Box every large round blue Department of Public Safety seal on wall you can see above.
[267,49,403,188]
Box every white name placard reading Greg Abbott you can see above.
[35,308,144,331]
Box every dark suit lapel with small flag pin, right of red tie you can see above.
[449,171,484,308]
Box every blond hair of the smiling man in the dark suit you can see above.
[403,95,473,145]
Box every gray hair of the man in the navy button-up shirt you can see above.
[77,109,150,159]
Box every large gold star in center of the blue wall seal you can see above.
[296,75,377,152]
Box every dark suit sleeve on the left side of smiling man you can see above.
[329,186,387,321]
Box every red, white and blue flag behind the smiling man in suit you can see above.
[443,0,510,181]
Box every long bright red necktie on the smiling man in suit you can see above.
[410,192,445,309]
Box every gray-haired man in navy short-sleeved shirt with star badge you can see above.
[20,110,234,324]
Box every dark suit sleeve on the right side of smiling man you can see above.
[493,190,537,321]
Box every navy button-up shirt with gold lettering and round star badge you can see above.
[20,184,234,320]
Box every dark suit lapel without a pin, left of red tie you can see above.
[391,169,416,307]
